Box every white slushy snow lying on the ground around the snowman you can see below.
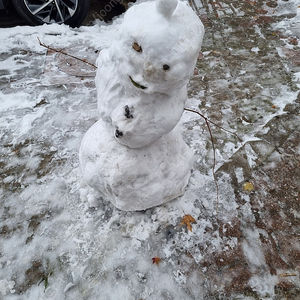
[0,1,299,300]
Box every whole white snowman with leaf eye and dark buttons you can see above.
[79,0,204,211]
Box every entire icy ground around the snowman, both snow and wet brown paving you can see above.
[0,0,300,300]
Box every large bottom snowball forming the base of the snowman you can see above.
[80,120,193,211]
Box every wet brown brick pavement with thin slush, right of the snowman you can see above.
[191,0,300,299]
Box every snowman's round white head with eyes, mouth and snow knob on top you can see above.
[110,0,204,94]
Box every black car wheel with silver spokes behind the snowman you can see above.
[12,0,90,27]
